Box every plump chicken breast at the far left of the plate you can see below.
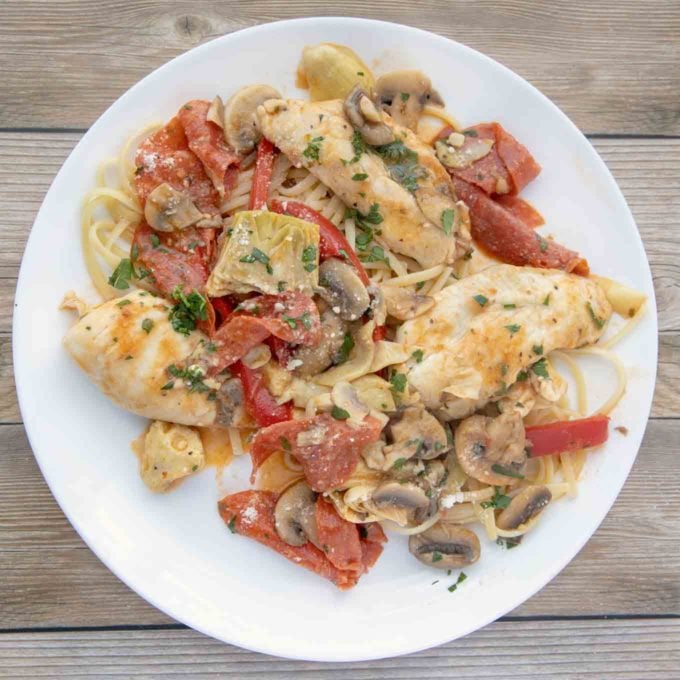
[64,291,219,425]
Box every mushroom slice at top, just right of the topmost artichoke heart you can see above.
[375,69,444,132]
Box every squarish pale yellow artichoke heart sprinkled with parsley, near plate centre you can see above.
[206,210,319,297]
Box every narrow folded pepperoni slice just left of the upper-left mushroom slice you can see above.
[177,99,240,197]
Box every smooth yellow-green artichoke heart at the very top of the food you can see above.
[298,43,375,102]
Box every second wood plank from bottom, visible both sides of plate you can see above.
[0,420,680,628]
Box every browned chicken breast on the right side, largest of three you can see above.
[397,264,612,419]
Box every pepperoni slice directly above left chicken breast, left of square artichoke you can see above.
[132,222,215,297]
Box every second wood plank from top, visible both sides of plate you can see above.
[0,133,680,331]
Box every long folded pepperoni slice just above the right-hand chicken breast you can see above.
[453,176,589,276]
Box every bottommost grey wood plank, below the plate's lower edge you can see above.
[0,619,680,680]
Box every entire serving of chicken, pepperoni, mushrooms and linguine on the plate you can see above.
[63,43,645,589]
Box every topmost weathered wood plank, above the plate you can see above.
[0,0,680,135]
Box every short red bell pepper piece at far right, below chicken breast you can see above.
[526,415,609,458]
